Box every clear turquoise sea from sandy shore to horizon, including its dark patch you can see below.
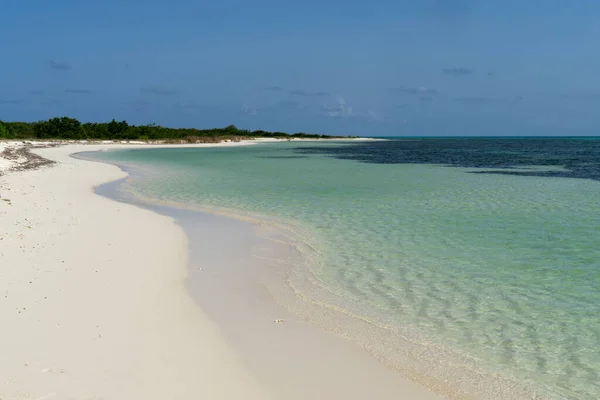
[86,139,600,399]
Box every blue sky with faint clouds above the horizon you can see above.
[0,0,600,136]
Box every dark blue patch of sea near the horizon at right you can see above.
[296,138,600,181]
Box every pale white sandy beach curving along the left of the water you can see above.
[0,139,439,400]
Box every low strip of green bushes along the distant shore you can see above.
[0,117,342,143]
